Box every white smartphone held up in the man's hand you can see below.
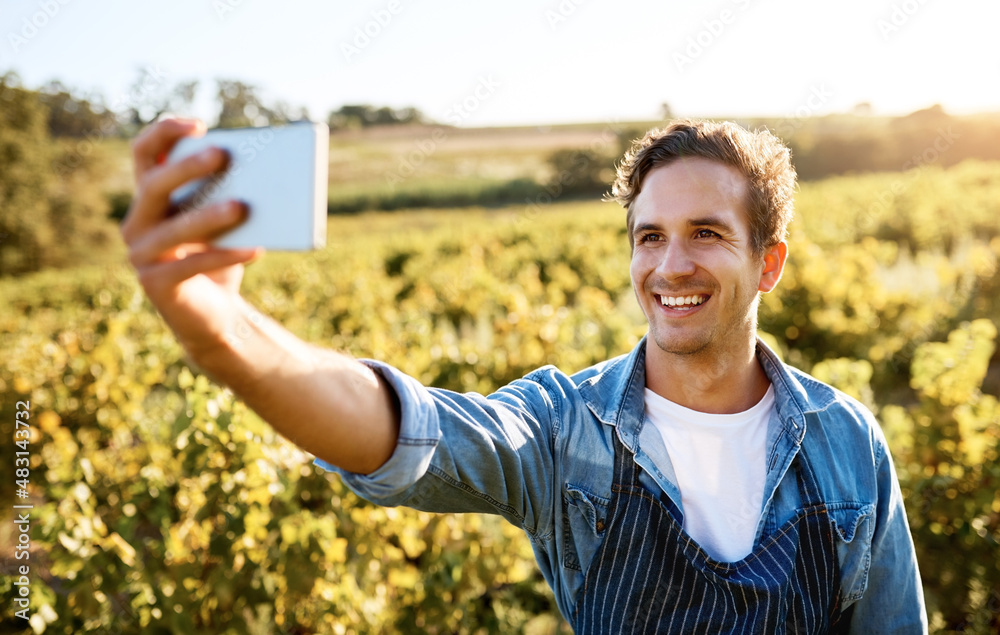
[167,121,330,251]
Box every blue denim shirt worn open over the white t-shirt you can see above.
[316,339,927,633]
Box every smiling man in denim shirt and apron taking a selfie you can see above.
[122,121,927,633]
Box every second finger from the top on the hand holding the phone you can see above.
[122,148,228,243]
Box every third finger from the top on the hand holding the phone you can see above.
[129,201,247,268]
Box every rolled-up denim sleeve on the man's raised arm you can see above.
[314,360,558,534]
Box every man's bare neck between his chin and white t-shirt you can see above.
[646,334,771,414]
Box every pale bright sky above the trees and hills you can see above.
[0,0,1000,127]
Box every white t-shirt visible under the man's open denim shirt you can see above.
[645,387,774,562]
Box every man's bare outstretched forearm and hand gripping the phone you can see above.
[121,119,399,474]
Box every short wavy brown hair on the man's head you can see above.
[608,119,795,255]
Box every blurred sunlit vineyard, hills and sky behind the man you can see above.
[0,0,1000,634]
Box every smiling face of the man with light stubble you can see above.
[630,157,784,355]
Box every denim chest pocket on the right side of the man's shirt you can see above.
[827,503,875,608]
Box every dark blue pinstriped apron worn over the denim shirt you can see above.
[573,435,850,634]
